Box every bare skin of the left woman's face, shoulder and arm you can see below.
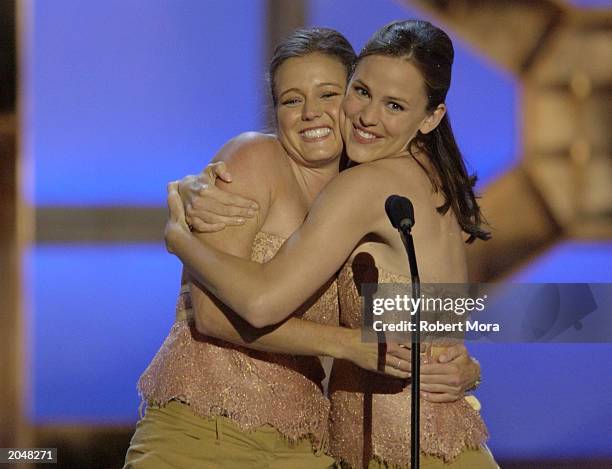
[178,54,410,378]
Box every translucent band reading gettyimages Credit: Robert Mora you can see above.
[361,283,612,343]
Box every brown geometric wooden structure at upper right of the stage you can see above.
[407,0,612,281]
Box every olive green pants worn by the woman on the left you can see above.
[124,401,334,469]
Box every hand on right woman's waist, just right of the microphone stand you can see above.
[421,344,480,402]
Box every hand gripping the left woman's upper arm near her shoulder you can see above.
[178,161,259,233]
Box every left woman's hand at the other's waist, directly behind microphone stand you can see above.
[335,329,411,379]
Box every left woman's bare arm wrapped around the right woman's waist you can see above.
[178,133,409,378]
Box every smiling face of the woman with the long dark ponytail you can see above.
[342,55,443,163]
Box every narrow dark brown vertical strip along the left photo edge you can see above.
[0,0,30,460]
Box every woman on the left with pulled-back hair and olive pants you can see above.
[125,28,440,468]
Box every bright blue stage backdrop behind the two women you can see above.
[24,0,612,458]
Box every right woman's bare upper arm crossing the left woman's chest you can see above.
[253,167,384,323]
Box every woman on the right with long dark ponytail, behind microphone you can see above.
[166,21,496,468]
